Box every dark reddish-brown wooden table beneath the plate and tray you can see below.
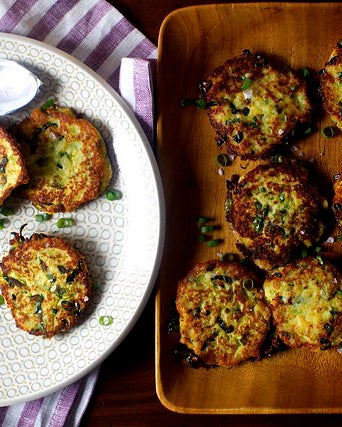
[81,0,342,427]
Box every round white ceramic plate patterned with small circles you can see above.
[0,33,164,406]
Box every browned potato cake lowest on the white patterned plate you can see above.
[0,232,91,338]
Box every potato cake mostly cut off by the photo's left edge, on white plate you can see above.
[0,127,29,206]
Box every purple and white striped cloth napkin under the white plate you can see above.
[0,0,157,427]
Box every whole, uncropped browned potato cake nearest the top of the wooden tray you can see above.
[202,49,311,159]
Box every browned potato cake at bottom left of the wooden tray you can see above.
[176,261,270,366]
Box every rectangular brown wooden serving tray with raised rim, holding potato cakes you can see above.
[156,2,342,414]
